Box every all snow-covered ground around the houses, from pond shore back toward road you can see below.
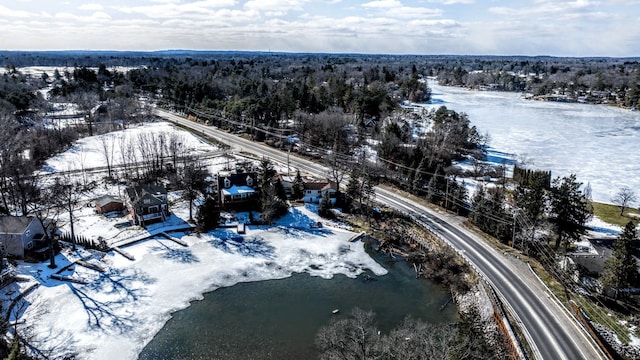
[0,123,386,359]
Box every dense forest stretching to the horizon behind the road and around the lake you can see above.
[0,51,640,360]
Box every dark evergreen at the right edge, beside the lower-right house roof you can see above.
[601,221,638,296]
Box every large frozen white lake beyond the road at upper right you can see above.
[429,82,640,203]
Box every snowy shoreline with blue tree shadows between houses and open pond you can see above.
[3,207,386,359]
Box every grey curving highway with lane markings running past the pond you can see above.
[156,109,605,360]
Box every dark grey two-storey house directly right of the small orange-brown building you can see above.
[126,185,169,226]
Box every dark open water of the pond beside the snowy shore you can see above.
[139,248,457,360]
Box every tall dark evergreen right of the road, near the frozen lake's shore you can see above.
[550,174,593,250]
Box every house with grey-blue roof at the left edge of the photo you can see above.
[0,216,47,258]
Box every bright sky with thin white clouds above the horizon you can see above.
[0,0,640,57]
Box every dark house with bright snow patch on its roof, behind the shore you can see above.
[217,172,258,207]
